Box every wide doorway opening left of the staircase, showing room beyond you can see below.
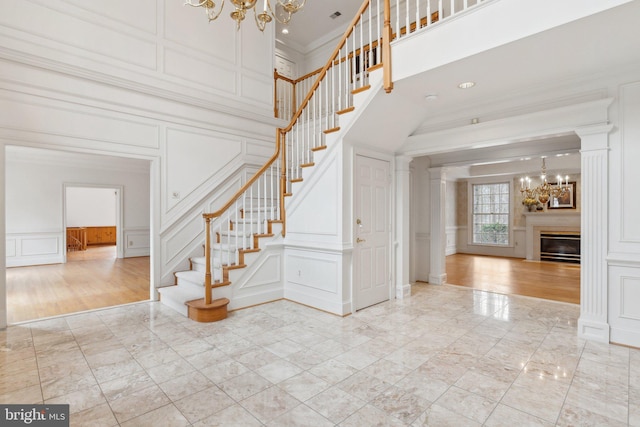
[5,146,152,324]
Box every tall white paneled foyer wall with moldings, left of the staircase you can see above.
[0,0,278,327]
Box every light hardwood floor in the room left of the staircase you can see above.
[7,246,150,324]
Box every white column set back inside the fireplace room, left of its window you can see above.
[429,168,447,285]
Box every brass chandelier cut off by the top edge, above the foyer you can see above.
[185,0,307,31]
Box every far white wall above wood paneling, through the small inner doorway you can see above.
[65,187,117,227]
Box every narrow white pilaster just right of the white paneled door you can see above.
[395,156,411,299]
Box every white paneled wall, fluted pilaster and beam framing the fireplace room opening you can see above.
[402,72,640,347]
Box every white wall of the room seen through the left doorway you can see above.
[5,147,150,266]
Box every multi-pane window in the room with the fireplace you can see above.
[472,182,510,246]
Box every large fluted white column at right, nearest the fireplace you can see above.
[576,125,613,343]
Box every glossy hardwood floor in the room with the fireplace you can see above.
[446,254,580,304]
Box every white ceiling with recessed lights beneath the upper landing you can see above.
[340,1,640,176]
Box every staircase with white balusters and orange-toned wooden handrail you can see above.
[158,0,486,322]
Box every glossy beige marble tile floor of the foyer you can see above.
[0,284,640,427]
